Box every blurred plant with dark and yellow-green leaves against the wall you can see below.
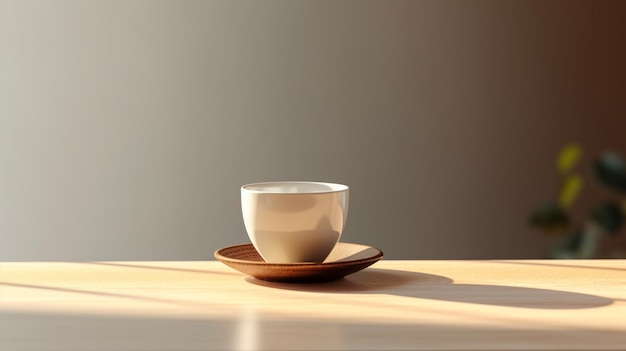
[529,144,626,258]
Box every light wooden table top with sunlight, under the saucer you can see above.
[0,260,626,351]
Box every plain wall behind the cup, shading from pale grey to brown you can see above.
[0,0,626,261]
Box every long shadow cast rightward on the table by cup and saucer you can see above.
[246,269,614,309]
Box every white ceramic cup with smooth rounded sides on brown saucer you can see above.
[241,181,348,263]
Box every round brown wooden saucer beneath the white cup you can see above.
[214,242,383,283]
